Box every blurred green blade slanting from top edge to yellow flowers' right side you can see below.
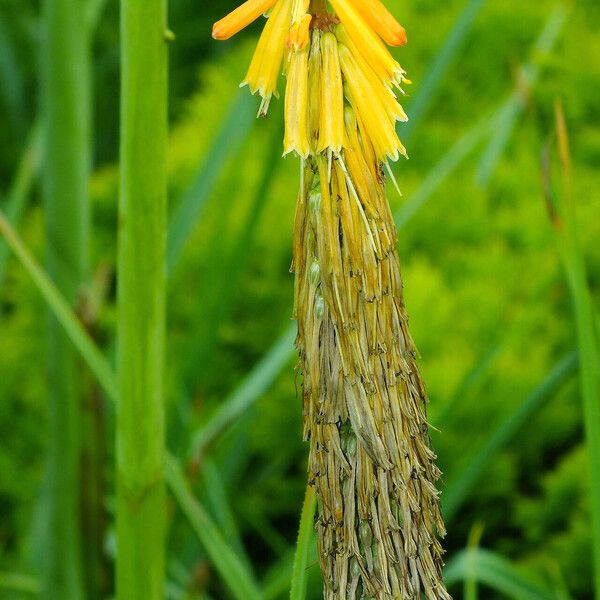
[402,0,485,142]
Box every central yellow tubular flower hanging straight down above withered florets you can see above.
[317,32,344,153]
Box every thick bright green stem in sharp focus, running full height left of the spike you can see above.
[117,0,167,600]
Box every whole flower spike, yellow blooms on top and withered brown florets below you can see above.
[211,0,450,600]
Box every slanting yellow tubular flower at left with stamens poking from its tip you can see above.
[240,0,292,115]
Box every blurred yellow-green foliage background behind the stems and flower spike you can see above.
[0,0,600,599]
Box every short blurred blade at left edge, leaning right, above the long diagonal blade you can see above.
[0,119,43,287]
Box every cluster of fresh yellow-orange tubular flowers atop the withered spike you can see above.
[213,0,410,161]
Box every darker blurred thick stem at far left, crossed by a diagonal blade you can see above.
[42,0,90,600]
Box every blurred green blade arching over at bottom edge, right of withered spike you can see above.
[444,548,557,600]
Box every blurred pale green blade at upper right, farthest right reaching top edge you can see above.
[477,3,569,186]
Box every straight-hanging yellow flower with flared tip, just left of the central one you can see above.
[283,46,310,158]
